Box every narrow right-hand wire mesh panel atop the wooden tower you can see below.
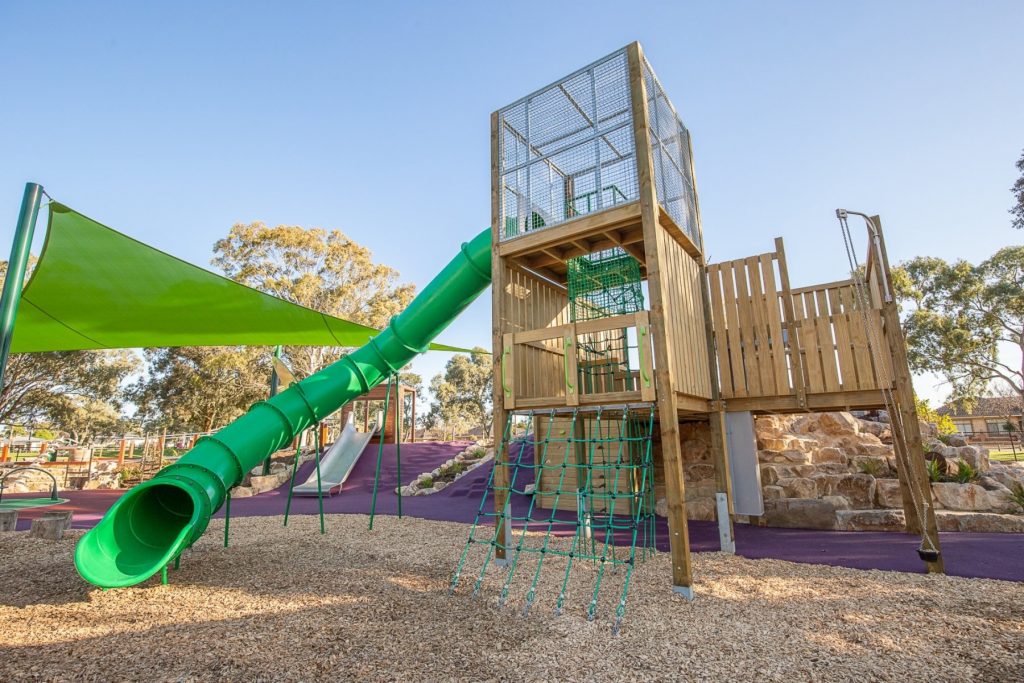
[643,59,702,249]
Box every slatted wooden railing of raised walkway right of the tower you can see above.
[707,240,893,409]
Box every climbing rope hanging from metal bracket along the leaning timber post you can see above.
[836,210,939,561]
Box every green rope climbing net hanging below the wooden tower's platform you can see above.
[451,404,655,633]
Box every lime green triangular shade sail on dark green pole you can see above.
[11,202,467,353]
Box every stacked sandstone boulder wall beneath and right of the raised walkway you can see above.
[654,413,1024,532]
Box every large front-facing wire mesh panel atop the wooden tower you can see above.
[498,49,639,240]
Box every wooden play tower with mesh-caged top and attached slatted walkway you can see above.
[490,43,941,597]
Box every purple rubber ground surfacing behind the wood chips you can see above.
[4,441,1024,582]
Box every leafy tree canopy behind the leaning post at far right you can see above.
[894,247,1024,411]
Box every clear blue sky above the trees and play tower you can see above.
[0,0,1024,397]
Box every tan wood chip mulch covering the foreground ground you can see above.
[0,515,1024,682]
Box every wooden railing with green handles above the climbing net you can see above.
[501,311,655,410]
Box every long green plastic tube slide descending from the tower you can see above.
[75,228,490,588]
